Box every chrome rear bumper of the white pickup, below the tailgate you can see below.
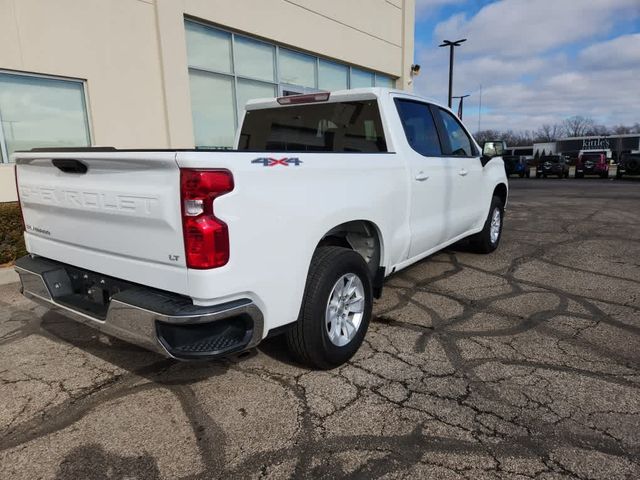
[15,255,264,360]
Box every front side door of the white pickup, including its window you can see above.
[433,107,482,239]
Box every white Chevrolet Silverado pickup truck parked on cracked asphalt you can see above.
[15,88,507,369]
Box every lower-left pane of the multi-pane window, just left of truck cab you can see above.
[189,70,236,148]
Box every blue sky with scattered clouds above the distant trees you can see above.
[414,0,640,131]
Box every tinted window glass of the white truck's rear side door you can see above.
[395,98,442,157]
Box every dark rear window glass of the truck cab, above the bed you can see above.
[238,100,387,153]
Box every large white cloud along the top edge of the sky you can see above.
[434,0,640,56]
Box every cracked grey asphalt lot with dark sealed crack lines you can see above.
[0,179,640,480]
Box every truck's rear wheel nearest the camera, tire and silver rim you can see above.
[287,247,373,370]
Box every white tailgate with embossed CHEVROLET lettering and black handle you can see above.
[16,151,187,293]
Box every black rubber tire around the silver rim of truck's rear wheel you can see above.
[287,247,373,370]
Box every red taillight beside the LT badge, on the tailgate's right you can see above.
[180,169,233,269]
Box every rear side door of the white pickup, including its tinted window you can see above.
[395,98,452,258]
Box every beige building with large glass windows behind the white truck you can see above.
[0,0,415,202]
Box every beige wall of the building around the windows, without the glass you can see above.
[0,0,415,201]
